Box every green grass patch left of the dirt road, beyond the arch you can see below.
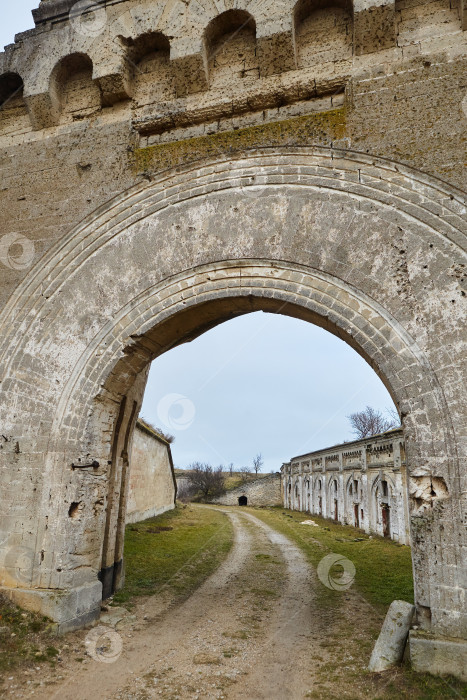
[114,505,233,604]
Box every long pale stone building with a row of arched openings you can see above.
[281,430,410,544]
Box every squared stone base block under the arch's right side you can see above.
[409,630,467,681]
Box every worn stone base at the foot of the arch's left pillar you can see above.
[0,581,102,634]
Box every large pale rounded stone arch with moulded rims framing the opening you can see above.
[0,148,466,636]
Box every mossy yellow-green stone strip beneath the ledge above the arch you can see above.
[133,107,346,173]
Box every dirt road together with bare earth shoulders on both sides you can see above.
[5,508,392,700]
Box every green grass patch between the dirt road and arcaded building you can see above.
[247,508,414,612]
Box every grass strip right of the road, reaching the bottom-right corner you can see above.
[238,508,467,700]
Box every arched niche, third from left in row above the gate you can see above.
[125,32,175,106]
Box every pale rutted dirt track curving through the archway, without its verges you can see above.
[27,511,334,700]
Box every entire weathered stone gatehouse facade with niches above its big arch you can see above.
[0,0,467,680]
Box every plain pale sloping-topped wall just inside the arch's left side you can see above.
[126,421,176,523]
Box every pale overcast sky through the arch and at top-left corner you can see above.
[0,0,393,471]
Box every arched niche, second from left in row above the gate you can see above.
[51,53,102,123]
